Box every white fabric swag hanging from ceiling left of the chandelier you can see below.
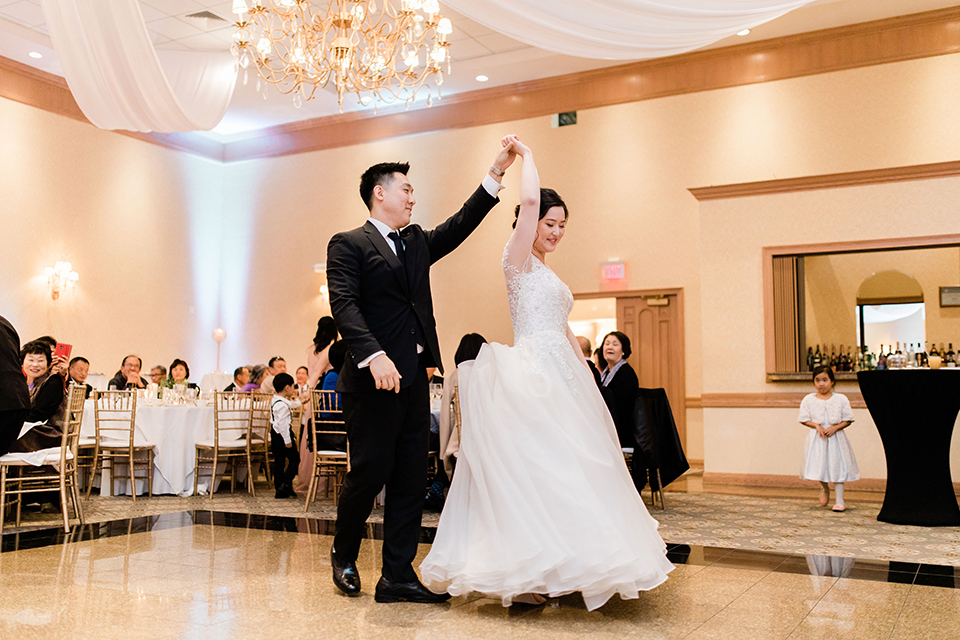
[43,0,237,132]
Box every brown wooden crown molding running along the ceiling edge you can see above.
[0,7,960,162]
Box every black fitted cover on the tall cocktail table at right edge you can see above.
[857,369,960,527]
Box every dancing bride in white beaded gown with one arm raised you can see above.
[420,136,673,610]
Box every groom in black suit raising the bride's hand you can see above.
[327,139,516,602]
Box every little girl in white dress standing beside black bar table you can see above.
[799,366,860,511]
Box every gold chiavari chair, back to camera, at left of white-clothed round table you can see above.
[87,389,157,501]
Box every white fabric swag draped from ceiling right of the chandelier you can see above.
[443,0,813,60]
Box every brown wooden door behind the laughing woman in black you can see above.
[617,291,687,446]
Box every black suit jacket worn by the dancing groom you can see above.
[327,186,499,393]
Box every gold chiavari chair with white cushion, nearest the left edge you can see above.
[0,386,86,533]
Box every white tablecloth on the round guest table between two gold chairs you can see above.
[80,400,213,495]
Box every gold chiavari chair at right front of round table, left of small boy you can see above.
[193,391,255,499]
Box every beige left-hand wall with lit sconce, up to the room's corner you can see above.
[0,100,223,375]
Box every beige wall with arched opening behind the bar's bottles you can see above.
[803,247,960,348]
